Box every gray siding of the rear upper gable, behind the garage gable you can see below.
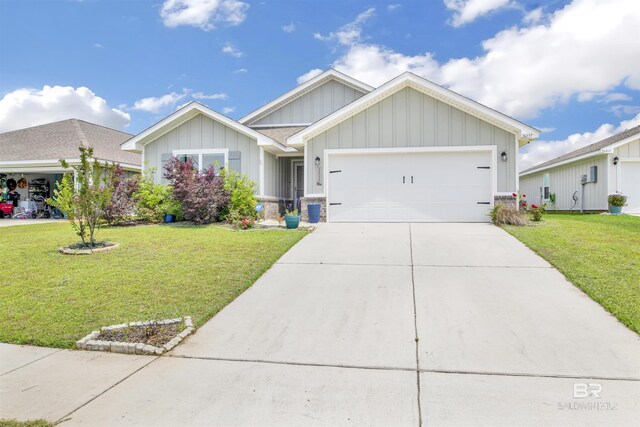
[250,80,364,126]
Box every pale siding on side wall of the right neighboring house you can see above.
[520,154,608,211]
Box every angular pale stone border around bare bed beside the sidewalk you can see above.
[76,316,194,356]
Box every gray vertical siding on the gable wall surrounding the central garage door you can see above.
[305,88,517,194]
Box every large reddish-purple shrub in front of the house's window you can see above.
[164,157,229,224]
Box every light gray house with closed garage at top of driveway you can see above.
[122,70,539,222]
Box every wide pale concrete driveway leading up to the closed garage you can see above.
[0,224,640,426]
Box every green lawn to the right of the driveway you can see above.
[504,214,640,334]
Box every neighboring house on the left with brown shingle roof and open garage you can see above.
[0,119,142,207]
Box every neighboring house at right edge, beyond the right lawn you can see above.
[520,126,640,213]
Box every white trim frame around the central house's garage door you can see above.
[323,145,498,222]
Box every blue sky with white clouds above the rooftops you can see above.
[0,0,640,170]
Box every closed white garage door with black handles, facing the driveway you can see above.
[328,151,494,222]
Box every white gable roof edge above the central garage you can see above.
[287,72,540,146]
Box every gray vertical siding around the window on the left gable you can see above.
[143,114,260,186]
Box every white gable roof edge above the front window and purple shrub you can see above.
[121,101,295,152]
